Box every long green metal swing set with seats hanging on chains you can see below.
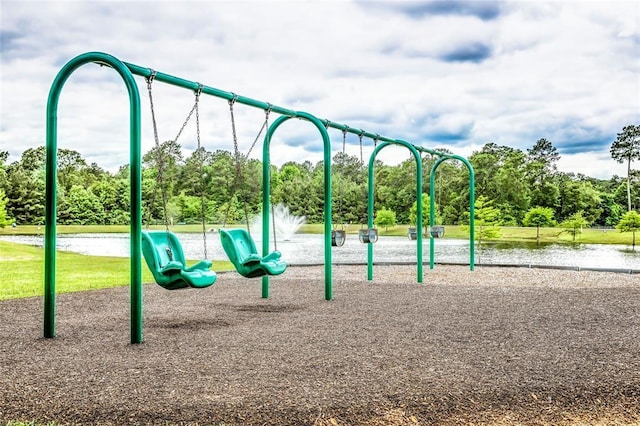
[44,52,474,343]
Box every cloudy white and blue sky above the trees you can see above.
[0,0,640,179]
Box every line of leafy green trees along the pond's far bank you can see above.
[0,125,640,233]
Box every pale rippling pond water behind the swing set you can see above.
[0,233,640,269]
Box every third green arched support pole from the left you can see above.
[367,139,422,283]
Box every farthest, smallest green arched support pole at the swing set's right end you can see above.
[428,152,476,271]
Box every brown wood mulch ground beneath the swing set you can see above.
[0,265,640,426]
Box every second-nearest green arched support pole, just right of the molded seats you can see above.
[262,112,333,300]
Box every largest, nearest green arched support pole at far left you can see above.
[44,52,142,343]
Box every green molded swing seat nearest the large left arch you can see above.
[142,231,216,290]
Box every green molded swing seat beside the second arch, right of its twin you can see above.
[220,228,287,278]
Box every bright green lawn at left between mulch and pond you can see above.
[0,241,232,300]
